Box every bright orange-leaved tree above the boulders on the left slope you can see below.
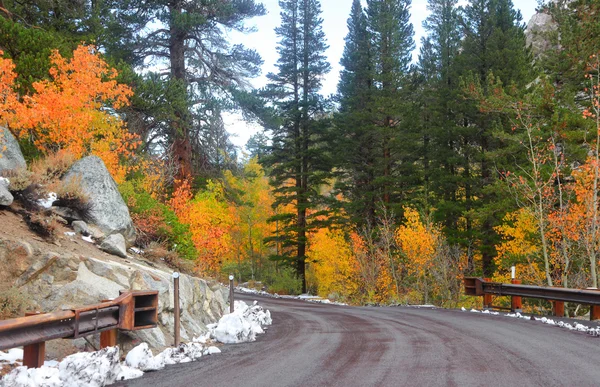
[0,45,139,182]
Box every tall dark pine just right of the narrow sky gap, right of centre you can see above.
[415,0,472,266]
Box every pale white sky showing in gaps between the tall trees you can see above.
[224,0,537,148]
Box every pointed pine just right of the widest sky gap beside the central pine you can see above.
[334,0,380,226]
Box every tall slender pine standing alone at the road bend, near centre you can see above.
[266,0,330,292]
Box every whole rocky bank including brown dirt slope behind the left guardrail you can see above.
[0,213,228,356]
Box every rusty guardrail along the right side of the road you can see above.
[464,277,600,320]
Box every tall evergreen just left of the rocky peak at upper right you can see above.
[458,0,533,275]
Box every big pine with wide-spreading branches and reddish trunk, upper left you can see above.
[107,0,265,178]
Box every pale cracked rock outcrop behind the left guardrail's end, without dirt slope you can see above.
[6,247,228,350]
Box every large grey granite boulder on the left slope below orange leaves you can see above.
[64,156,135,243]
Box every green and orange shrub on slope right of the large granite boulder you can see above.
[119,180,198,259]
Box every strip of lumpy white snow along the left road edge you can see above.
[0,301,272,387]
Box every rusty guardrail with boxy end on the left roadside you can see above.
[0,290,158,367]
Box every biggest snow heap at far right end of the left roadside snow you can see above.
[208,301,273,344]
